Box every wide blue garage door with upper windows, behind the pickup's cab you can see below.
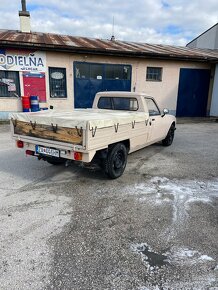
[74,62,131,108]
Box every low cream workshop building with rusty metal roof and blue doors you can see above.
[0,30,218,119]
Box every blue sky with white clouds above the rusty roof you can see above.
[0,0,218,45]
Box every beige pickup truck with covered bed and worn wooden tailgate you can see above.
[10,92,176,178]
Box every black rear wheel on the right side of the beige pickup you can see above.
[105,143,127,179]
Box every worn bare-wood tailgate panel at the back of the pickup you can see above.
[13,121,83,145]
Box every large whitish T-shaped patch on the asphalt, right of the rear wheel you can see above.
[124,177,218,240]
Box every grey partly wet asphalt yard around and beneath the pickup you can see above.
[0,123,218,290]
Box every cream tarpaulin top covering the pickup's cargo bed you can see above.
[10,109,149,130]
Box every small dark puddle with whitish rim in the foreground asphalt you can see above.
[134,244,169,268]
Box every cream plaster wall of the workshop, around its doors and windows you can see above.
[0,48,210,119]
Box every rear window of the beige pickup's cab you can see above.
[98,97,138,111]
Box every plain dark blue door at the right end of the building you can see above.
[176,68,210,117]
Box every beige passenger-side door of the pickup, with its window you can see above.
[145,98,166,143]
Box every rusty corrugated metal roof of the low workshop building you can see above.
[0,30,218,62]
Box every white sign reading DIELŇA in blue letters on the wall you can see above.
[0,50,46,72]
